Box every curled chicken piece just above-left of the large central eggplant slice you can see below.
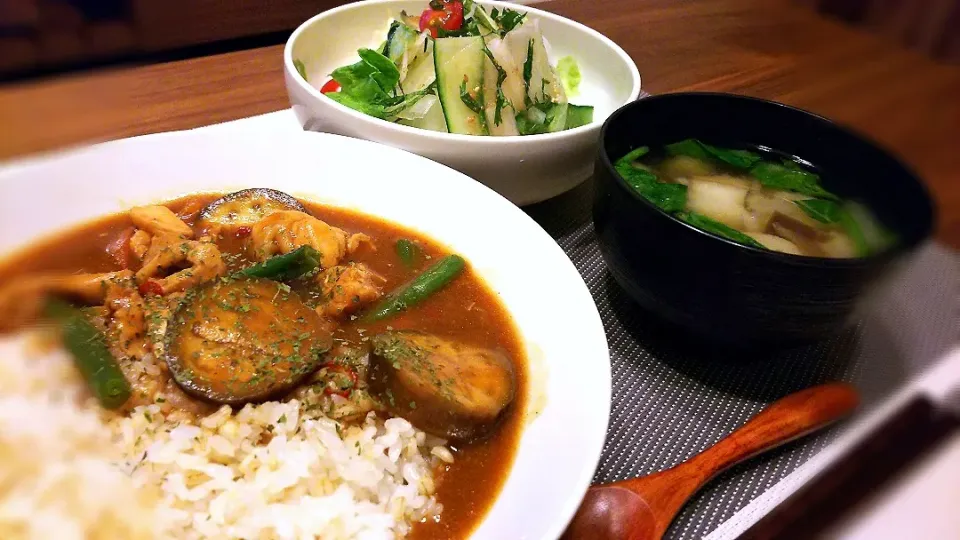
[136,234,227,296]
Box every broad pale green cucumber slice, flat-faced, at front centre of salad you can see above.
[433,36,488,135]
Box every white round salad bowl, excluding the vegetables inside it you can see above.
[283,0,640,205]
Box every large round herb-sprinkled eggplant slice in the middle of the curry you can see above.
[164,278,333,405]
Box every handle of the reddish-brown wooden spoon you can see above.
[687,383,859,482]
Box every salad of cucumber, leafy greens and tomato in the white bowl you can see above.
[304,0,593,136]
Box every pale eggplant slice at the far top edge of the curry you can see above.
[197,188,307,229]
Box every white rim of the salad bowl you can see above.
[283,0,641,145]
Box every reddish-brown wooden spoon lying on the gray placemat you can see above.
[561,383,859,540]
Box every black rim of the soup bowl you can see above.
[598,92,937,268]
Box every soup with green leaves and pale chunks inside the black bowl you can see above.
[615,139,895,258]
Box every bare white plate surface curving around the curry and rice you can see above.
[0,130,610,540]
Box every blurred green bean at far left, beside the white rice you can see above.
[45,300,131,409]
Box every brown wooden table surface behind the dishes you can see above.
[0,0,960,247]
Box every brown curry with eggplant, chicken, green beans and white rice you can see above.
[0,189,526,539]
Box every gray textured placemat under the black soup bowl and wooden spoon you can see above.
[526,182,960,539]
